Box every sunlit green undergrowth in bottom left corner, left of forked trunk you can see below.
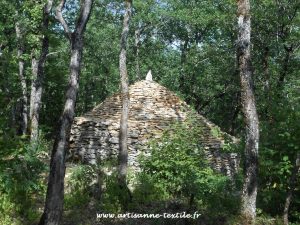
[0,137,49,225]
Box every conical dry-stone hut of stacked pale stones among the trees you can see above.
[70,77,239,176]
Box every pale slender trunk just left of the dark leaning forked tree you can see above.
[30,0,53,143]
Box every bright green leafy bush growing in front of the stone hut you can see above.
[135,116,238,217]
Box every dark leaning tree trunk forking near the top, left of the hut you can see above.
[40,0,93,225]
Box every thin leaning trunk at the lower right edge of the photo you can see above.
[283,152,300,225]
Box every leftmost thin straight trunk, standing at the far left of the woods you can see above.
[15,22,28,135]
